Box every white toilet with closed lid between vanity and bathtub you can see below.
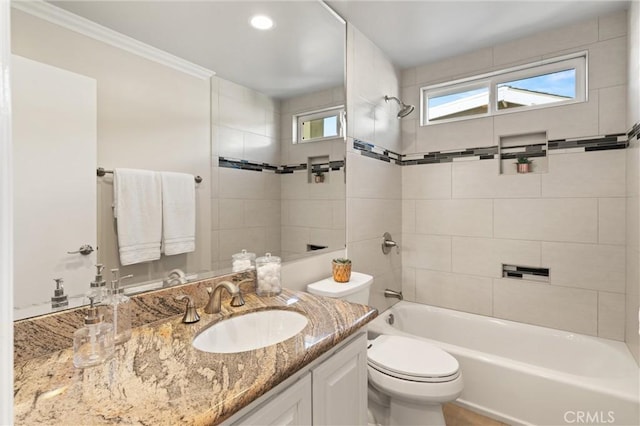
[307,272,463,426]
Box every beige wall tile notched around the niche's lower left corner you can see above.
[452,160,540,198]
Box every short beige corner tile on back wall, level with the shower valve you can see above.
[401,234,451,271]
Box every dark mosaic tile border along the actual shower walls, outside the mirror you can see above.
[353,131,640,166]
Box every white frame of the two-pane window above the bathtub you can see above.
[420,51,589,126]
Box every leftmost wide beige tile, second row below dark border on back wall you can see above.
[416,200,493,237]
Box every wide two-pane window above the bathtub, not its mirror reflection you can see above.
[421,52,587,125]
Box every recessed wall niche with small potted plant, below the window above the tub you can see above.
[498,132,549,175]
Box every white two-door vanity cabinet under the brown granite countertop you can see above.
[229,332,367,426]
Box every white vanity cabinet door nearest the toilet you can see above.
[312,334,367,426]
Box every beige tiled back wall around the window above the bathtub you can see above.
[399,13,627,340]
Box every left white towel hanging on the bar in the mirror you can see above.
[113,169,162,265]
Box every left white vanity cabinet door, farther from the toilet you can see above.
[235,374,311,426]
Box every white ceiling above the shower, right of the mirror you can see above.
[327,0,629,68]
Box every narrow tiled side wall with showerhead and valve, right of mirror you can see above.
[347,24,402,310]
